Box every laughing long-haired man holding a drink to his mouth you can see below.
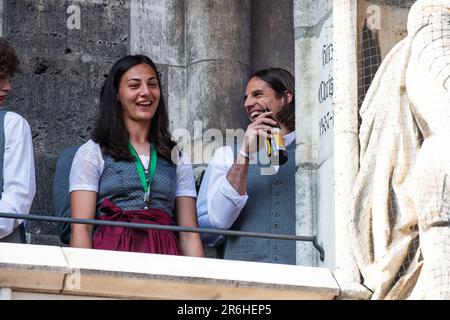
[197,68,296,264]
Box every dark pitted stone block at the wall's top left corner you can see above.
[4,0,129,59]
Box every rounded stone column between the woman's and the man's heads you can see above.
[186,0,251,165]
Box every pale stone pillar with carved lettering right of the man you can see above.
[294,0,334,269]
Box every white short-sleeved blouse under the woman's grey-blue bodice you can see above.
[69,140,197,198]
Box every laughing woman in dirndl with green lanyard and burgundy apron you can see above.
[70,55,204,256]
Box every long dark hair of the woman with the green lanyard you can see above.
[92,55,176,161]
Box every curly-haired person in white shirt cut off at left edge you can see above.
[0,38,36,243]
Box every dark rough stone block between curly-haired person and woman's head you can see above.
[8,57,110,155]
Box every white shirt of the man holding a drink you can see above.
[197,131,295,246]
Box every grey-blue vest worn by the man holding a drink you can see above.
[224,143,297,264]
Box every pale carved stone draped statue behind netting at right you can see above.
[349,0,450,299]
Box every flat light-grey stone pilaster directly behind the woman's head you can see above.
[130,0,188,132]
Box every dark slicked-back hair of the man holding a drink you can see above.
[250,68,295,131]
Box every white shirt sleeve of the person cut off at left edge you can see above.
[0,112,36,239]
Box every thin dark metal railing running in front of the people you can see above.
[0,213,325,261]
